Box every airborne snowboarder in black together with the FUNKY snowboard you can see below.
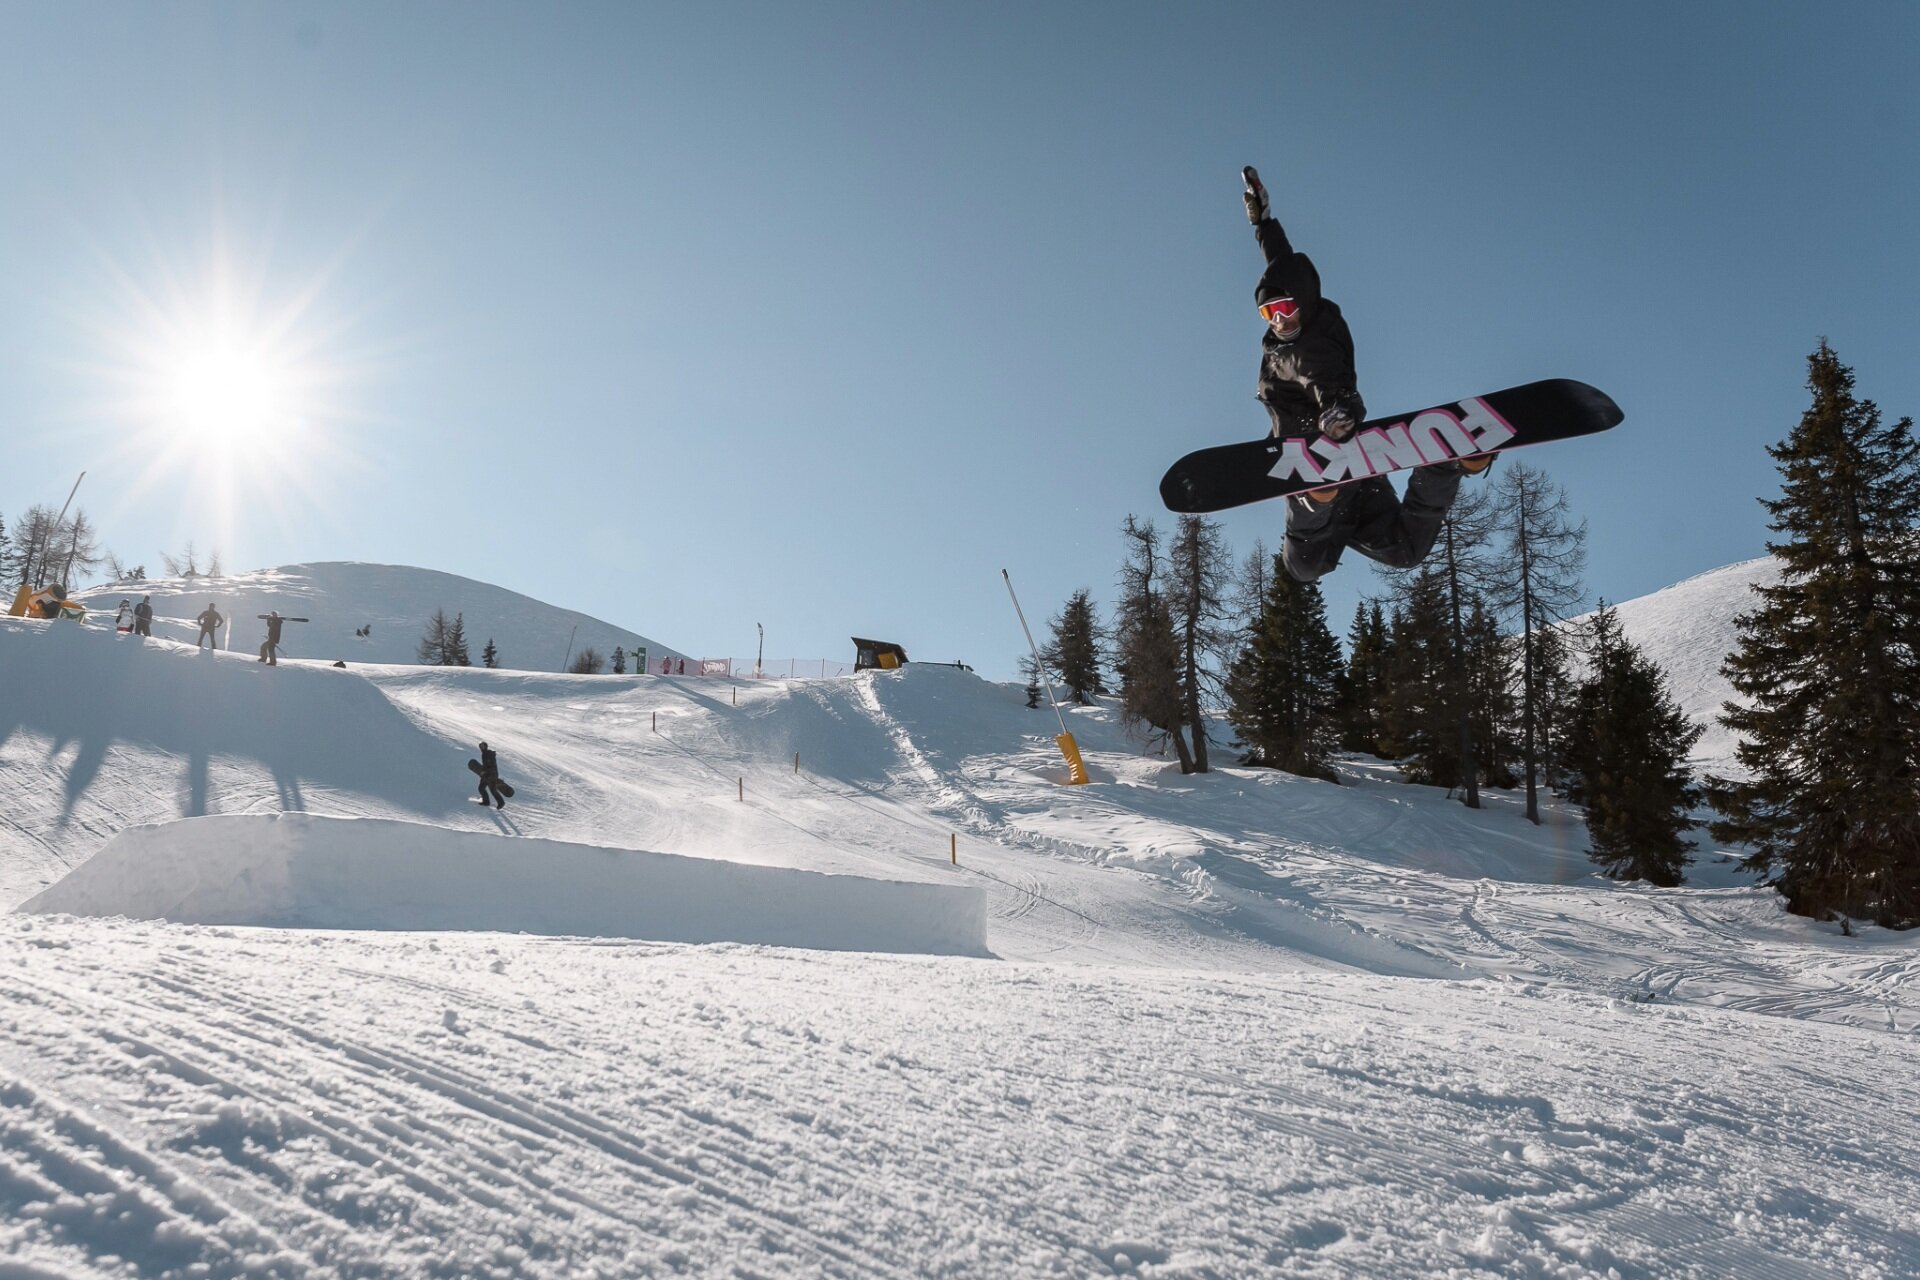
[1160,165,1620,581]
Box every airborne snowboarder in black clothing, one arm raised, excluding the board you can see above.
[1240,165,1494,581]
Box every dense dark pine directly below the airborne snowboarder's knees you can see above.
[1227,558,1340,781]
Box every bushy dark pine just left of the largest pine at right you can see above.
[1565,604,1703,887]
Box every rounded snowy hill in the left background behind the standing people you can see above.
[77,560,687,672]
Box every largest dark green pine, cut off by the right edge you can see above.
[1713,340,1920,927]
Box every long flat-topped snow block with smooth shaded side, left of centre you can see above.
[19,814,987,956]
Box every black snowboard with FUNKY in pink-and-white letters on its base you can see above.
[1160,378,1626,512]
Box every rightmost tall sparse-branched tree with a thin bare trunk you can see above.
[1494,462,1586,823]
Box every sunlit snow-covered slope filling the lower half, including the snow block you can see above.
[0,566,1920,1280]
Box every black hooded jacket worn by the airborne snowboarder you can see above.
[1254,217,1367,436]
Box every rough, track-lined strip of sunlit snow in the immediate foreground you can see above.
[0,915,1920,1280]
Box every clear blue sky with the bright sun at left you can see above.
[0,2,1920,679]
